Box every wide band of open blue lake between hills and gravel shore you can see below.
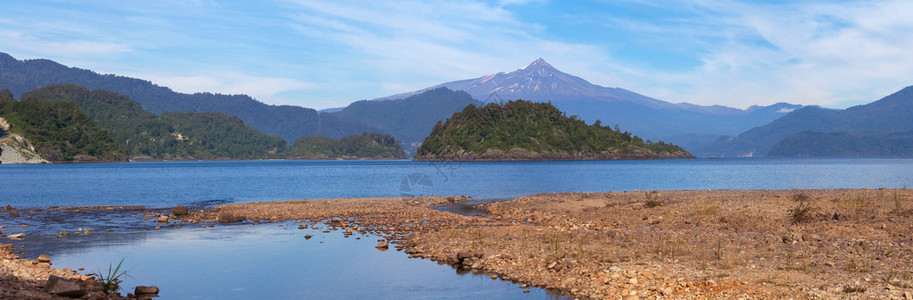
[0,158,913,208]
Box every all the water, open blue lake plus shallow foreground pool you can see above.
[0,158,913,299]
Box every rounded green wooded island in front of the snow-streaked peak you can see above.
[415,100,694,161]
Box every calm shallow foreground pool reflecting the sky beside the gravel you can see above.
[14,222,566,299]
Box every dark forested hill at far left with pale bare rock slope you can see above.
[0,90,127,162]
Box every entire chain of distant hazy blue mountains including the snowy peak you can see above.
[0,53,913,157]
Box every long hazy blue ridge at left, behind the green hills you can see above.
[0,53,376,141]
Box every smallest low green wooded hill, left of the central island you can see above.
[288,133,406,159]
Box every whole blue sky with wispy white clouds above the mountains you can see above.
[0,0,913,109]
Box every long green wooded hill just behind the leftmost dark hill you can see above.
[22,84,286,159]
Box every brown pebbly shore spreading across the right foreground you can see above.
[175,189,913,299]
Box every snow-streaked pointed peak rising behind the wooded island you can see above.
[374,58,802,156]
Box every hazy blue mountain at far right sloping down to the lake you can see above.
[700,87,913,157]
